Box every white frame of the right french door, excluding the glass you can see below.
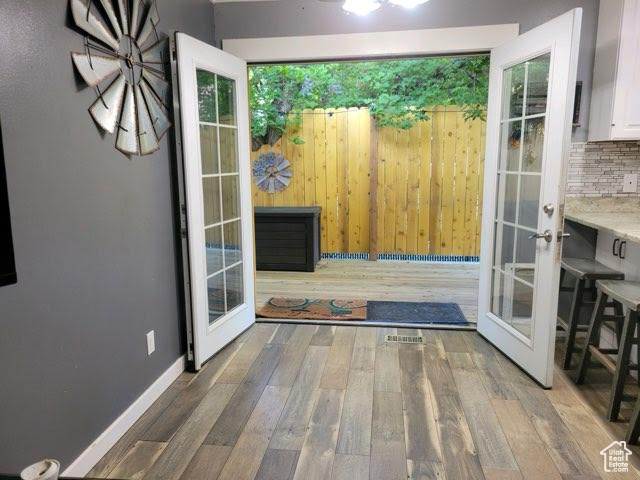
[478,8,582,387]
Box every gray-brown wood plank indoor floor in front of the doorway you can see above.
[90,324,640,480]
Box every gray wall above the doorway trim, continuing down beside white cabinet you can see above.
[214,0,599,141]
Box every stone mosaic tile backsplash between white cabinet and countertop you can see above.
[567,142,640,197]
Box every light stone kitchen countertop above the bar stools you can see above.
[564,197,640,243]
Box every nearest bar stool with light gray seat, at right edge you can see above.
[576,280,640,421]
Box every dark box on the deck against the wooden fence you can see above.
[255,207,320,272]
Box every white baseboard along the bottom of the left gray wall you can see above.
[62,355,185,477]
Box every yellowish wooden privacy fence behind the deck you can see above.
[251,107,485,256]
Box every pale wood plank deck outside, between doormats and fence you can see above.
[256,260,479,323]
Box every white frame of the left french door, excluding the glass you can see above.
[175,33,255,370]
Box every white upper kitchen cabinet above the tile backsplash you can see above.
[589,0,640,142]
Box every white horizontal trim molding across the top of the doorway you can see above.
[222,23,520,63]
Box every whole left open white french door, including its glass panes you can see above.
[172,33,255,370]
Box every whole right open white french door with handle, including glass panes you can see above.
[478,9,582,387]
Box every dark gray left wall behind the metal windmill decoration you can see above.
[0,0,213,472]
